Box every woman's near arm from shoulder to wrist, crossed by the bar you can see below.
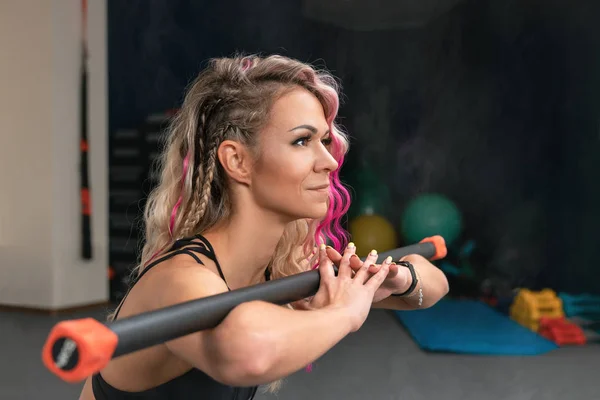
[152,261,360,386]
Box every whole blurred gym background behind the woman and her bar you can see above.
[0,0,600,399]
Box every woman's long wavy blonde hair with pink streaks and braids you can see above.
[117,55,349,391]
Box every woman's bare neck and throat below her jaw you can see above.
[203,206,286,290]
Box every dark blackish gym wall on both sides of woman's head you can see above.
[109,0,600,292]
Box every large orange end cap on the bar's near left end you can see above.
[42,318,119,383]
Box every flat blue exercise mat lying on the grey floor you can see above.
[394,299,558,355]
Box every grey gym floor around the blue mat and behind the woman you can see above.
[0,310,600,400]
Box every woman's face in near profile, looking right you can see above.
[252,88,338,220]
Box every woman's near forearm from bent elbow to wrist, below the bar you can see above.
[204,301,352,386]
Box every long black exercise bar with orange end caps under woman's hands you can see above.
[42,236,446,382]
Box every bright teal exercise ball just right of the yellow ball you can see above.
[401,193,462,245]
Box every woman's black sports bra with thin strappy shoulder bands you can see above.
[92,235,270,400]
